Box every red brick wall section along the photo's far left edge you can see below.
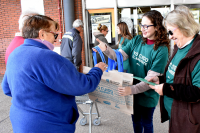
[0,0,21,76]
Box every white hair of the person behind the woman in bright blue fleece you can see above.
[18,11,39,31]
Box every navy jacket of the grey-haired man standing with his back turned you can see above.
[60,28,82,66]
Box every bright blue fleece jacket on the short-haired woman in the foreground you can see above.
[2,39,102,133]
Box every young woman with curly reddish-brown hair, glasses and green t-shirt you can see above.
[94,10,169,133]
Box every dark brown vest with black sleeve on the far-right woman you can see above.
[159,35,200,133]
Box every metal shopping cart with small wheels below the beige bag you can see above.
[75,94,101,133]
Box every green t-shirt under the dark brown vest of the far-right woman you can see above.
[164,39,200,118]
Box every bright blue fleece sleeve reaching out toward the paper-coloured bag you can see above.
[50,64,103,96]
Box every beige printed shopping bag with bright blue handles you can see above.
[83,46,133,114]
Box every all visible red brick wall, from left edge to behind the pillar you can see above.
[0,0,85,76]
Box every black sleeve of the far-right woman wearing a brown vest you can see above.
[163,83,200,102]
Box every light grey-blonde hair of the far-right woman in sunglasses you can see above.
[163,6,200,37]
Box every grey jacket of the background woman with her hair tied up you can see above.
[93,32,109,64]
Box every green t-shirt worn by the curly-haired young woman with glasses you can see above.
[122,35,168,107]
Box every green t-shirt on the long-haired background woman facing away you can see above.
[118,37,131,73]
